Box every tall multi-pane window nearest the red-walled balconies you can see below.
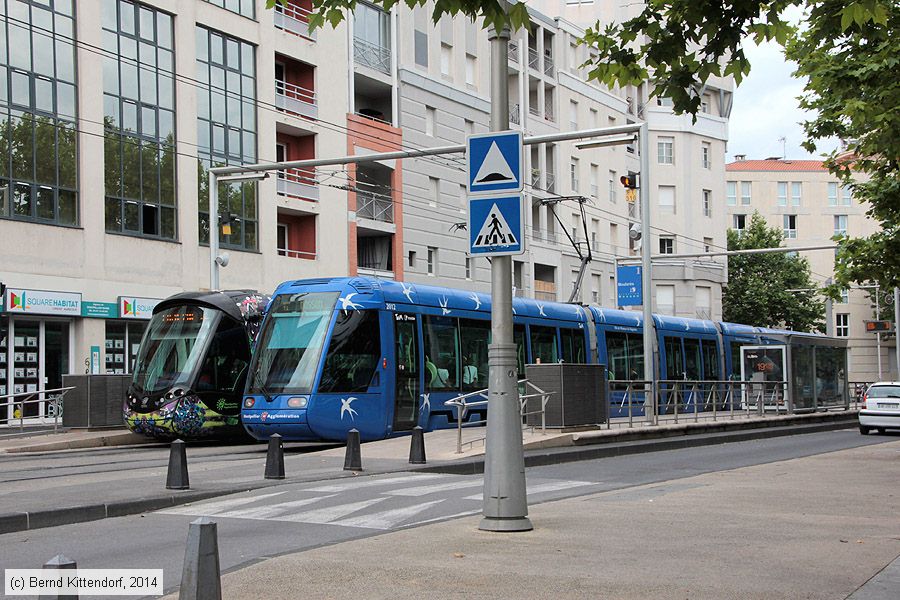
[196,26,258,250]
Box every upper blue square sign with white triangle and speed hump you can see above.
[466,131,524,194]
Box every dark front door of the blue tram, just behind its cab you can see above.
[394,313,419,431]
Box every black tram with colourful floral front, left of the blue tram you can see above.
[123,290,269,440]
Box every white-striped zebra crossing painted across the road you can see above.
[157,473,598,531]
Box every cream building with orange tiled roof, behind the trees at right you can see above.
[726,156,884,381]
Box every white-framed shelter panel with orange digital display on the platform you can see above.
[741,346,788,410]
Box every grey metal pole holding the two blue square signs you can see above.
[478,23,533,531]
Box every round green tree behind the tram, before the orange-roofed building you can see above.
[722,212,824,331]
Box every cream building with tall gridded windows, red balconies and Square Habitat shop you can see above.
[0,0,356,417]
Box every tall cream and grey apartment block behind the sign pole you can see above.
[393,2,731,318]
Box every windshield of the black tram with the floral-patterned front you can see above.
[132,306,221,394]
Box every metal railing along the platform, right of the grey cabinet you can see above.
[606,379,808,428]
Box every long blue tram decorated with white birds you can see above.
[241,277,844,440]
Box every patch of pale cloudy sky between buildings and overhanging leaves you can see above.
[727,41,837,162]
